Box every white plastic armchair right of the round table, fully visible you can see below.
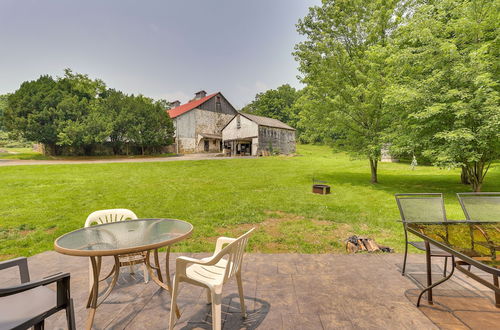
[170,228,255,330]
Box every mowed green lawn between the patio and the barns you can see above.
[0,145,500,259]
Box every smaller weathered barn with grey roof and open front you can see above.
[222,112,295,156]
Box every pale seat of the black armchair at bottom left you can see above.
[0,286,57,329]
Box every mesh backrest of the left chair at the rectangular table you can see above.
[394,193,447,223]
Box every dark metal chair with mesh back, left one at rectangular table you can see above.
[394,193,451,276]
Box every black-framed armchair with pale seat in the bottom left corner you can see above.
[0,258,76,330]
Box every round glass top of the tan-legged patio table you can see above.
[55,219,193,251]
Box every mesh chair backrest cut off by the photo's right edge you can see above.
[457,192,500,222]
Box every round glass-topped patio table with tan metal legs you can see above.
[54,219,193,329]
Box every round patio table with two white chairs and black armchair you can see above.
[0,209,253,329]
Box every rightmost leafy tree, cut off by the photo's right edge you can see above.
[387,0,500,191]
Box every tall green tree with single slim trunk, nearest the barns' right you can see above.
[294,0,407,183]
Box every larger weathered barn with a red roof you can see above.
[168,91,238,153]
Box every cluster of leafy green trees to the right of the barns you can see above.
[243,0,500,191]
